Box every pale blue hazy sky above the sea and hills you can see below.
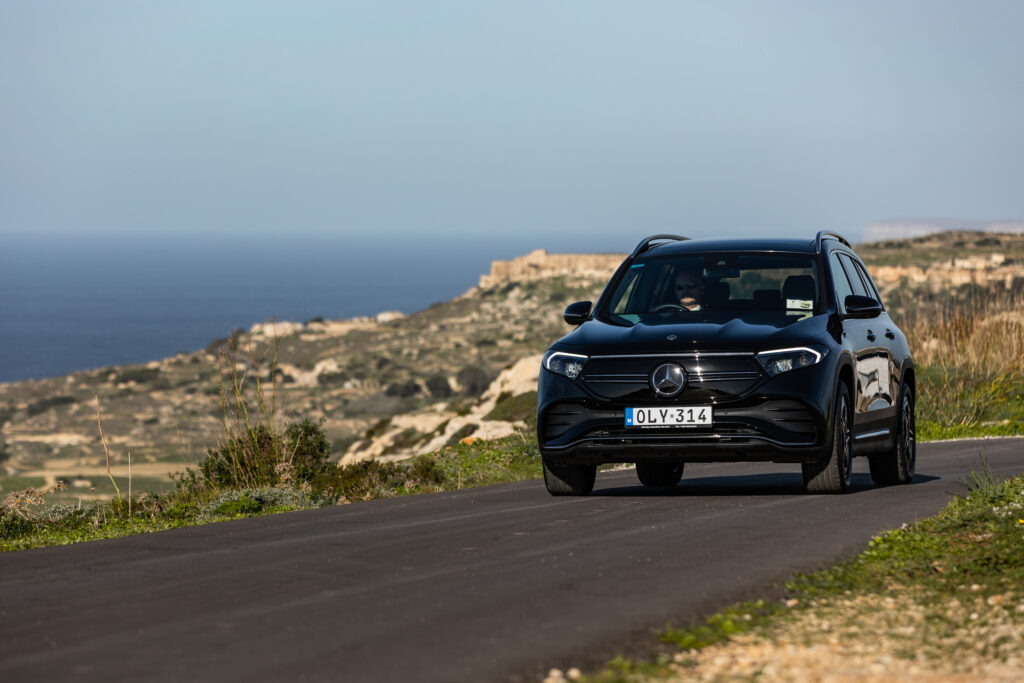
[0,0,1024,245]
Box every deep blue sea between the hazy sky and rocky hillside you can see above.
[0,233,614,382]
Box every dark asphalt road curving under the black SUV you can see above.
[0,439,1024,683]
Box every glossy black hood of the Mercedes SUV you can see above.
[554,314,828,355]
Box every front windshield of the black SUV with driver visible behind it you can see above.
[599,252,819,326]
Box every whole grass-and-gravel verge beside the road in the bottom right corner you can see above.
[586,465,1024,683]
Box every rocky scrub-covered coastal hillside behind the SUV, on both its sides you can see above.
[0,231,1024,499]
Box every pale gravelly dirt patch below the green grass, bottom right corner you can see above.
[670,586,1024,681]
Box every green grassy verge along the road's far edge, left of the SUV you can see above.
[0,435,541,551]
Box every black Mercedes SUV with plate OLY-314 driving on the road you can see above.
[537,232,916,496]
